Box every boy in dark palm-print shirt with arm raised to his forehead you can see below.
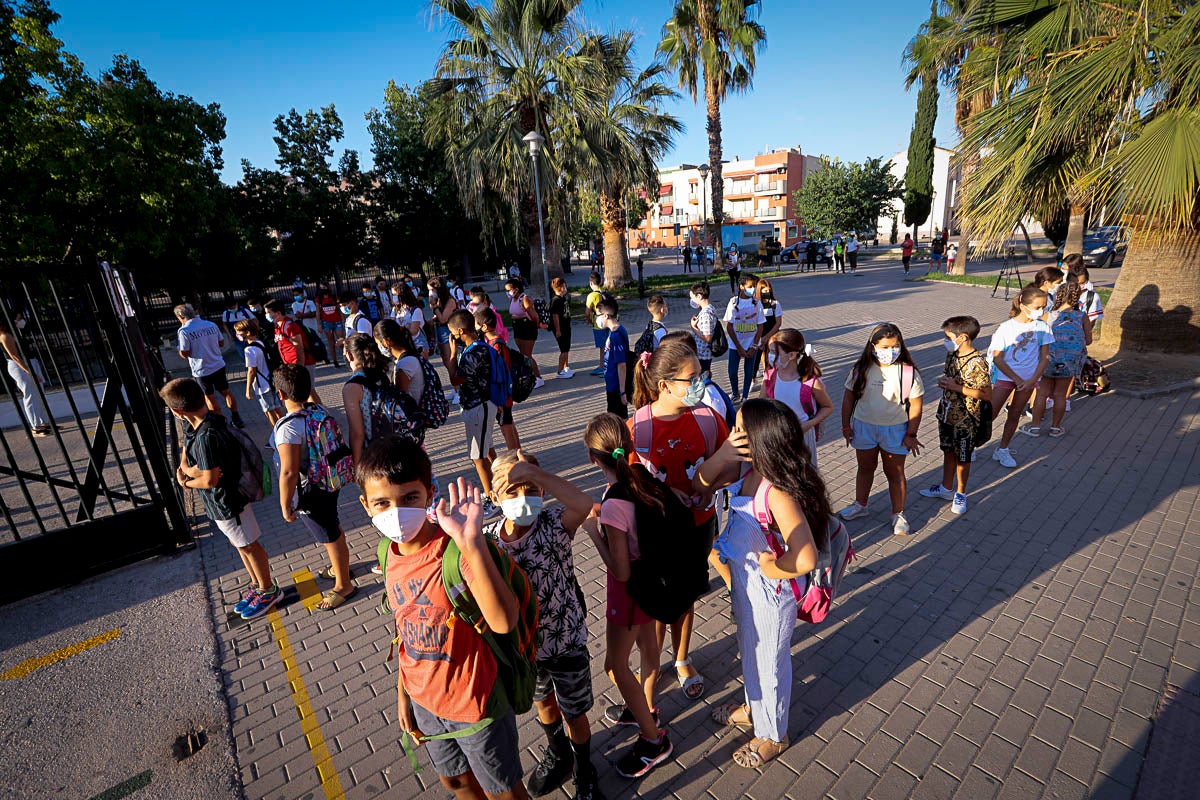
[484,450,602,800]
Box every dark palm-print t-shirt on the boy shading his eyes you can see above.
[484,506,588,661]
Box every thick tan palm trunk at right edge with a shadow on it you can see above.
[1099,228,1200,353]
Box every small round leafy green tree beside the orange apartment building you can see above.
[794,158,904,236]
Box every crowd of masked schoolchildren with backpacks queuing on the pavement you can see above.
[162,257,1102,799]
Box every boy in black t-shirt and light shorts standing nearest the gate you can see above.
[160,379,283,619]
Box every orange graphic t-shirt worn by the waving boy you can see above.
[385,530,497,722]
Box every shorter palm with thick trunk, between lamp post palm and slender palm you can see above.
[572,31,683,288]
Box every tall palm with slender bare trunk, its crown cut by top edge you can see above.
[659,0,767,270]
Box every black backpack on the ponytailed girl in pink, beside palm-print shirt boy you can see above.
[605,464,713,622]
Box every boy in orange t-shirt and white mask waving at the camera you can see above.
[358,437,529,800]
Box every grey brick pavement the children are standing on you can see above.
[192,263,1200,800]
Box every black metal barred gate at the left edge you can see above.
[0,264,191,603]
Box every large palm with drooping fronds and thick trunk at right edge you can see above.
[945,0,1200,351]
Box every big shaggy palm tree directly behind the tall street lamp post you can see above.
[427,0,602,289]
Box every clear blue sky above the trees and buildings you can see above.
[52,0,955,182]
